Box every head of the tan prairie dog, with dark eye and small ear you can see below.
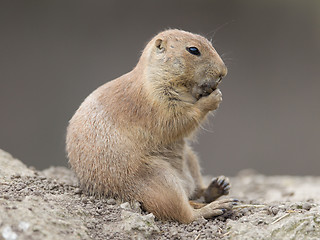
[142,29,227,103]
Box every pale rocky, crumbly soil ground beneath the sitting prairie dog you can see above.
[0,150,320,240]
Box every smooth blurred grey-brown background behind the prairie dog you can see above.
[0,0,320,175]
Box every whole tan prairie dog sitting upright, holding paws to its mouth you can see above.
[66,30,236,223]
